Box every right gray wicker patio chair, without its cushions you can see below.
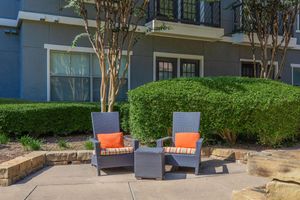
[156,112,203,175]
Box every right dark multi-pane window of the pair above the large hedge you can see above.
[180,59,200,77]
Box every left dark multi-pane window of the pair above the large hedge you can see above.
[156,57,177,80]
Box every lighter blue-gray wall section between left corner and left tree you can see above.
[21,21,89,101]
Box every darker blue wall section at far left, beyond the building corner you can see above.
[0,0,20,98]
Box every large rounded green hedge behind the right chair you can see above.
[129,77,300,146]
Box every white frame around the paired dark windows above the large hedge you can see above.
[153,52,204,81]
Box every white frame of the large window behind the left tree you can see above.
[44,44,133,102]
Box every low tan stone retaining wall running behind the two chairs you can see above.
[0,147,252,186]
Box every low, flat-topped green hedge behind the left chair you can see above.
[0,103,128,136]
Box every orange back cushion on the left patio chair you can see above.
[97,132,124,149]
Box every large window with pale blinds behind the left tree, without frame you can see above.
[50,51,127,102]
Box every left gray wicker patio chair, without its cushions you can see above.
[91,112,139,176]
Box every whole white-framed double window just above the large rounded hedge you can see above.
[154,53,203,80]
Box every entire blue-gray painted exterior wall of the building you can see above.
[0,0,300,101]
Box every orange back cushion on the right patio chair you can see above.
[175,133,200,148]
